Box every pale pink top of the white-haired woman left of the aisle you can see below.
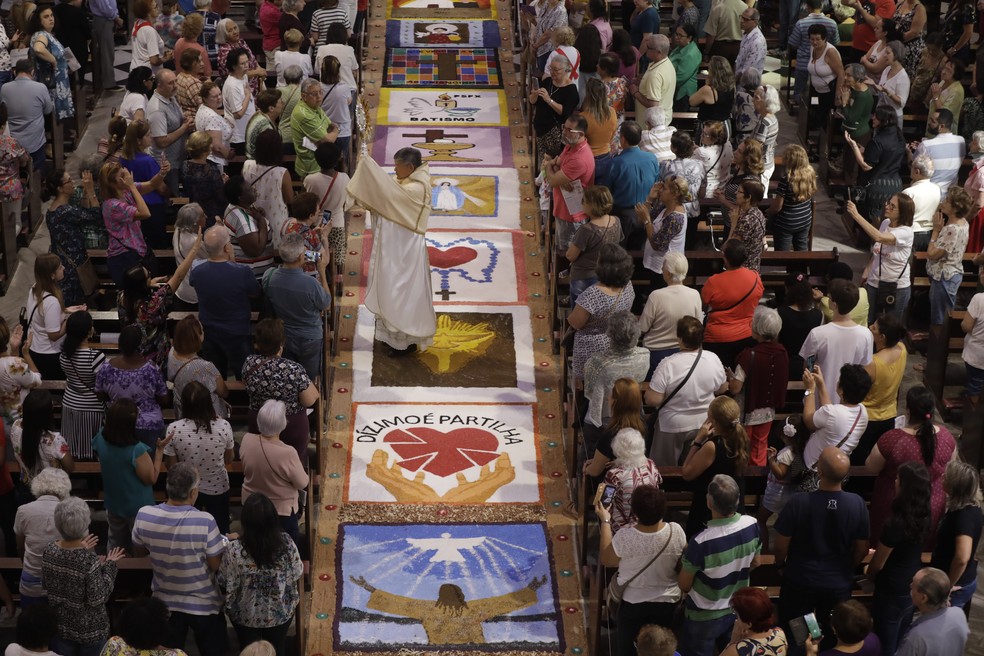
[239,433,308,516]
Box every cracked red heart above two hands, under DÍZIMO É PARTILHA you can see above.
[383,426,499,477]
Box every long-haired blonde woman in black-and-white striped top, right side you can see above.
[768,144,817,251]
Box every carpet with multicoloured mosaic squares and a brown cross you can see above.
[383,48,502,89]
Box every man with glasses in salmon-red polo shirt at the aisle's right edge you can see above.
[543,114,594,252]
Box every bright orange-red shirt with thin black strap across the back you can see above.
[700,267,765,343]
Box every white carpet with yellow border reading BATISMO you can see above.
[377,88,508,126]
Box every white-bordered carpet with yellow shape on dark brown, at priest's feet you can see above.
[352,305,536,403]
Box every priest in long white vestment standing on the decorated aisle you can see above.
[348,148,437,352]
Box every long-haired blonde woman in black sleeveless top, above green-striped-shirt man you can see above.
[682,396,749,537]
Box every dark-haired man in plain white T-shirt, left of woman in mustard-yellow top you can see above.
[799,280,874,404]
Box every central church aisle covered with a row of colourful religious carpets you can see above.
[304,0,587,656]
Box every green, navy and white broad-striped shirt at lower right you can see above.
[683,513,762,621]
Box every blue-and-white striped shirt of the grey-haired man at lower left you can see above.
[132,503,225,615]
